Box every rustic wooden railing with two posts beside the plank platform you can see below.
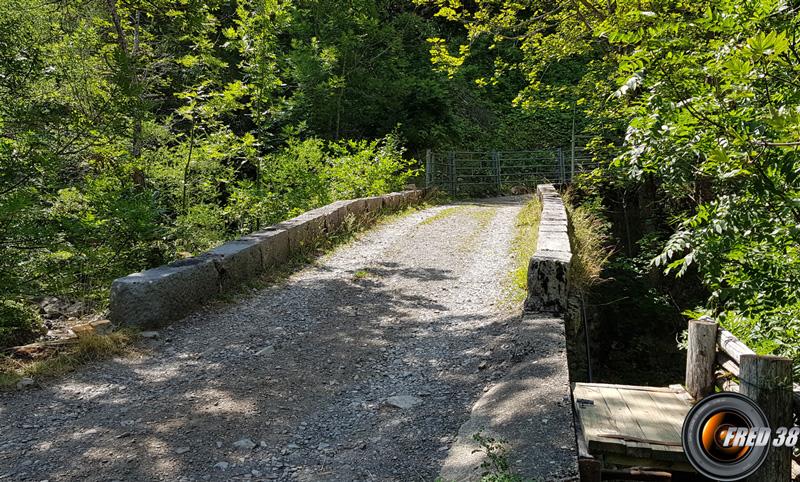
[686,317,800,482]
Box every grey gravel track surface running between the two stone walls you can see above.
[0,197,568,481]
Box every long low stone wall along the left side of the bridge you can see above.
[109,190,432,327]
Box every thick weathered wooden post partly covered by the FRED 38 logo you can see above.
[739,355,793,482]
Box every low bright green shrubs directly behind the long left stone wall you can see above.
[0,135,416,312]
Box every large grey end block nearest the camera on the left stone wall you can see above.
[109,255,220,327]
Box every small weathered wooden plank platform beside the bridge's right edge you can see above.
[573,383,692,471]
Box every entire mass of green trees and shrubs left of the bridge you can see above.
[0,0,428,307]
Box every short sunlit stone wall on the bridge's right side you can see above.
[525,184,572,313]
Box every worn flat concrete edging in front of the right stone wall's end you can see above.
[442,316,577,480]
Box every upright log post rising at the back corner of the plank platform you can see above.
[686,320,717,400]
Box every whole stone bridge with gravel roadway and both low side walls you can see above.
[0,186,577,481]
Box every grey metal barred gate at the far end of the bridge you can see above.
[425,149,572,194]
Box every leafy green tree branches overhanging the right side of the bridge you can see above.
[418,0,800,372]
